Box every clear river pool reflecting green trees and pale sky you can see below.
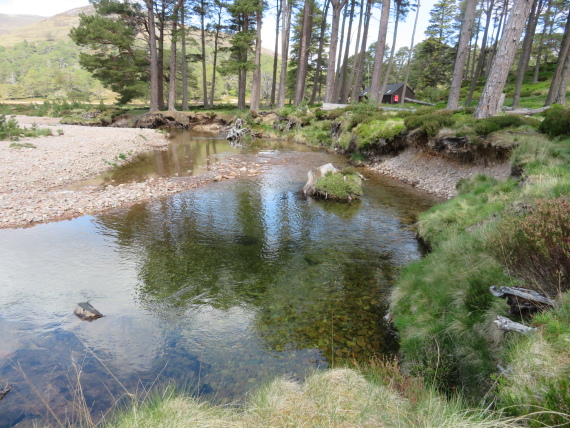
[0,135,436,427]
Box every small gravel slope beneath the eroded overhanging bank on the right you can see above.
[369,149,511,199]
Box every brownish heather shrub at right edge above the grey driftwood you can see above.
[488,197,570,296]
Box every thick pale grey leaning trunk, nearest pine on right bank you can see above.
[474,0,532,119]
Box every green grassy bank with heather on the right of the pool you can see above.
[391,133,570,408]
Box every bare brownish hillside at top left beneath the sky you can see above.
[0,6,95,47]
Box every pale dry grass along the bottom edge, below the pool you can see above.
[109,367,519,428]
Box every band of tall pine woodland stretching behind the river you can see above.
[0,0,570,117]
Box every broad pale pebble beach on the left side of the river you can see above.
[0,116,267,228]
